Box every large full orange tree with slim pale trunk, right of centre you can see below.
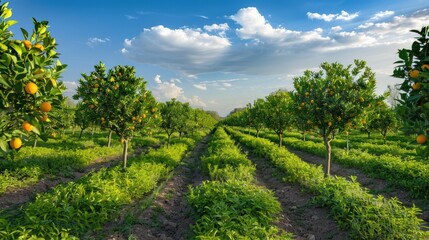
[293,60,376,176]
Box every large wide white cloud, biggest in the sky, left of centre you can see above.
[122,25,231,70]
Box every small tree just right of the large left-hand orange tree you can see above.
[160,98,190,147]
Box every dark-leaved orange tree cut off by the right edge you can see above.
[393,26,429,149]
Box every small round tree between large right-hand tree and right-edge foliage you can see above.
[369,102,398,144]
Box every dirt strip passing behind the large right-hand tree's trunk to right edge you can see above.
[288,148,429,226]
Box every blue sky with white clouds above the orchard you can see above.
[9,0,429,116]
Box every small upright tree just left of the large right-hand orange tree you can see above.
[265,90,292,147]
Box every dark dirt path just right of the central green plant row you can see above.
[244,150,347,240]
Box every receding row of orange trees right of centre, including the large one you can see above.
[224,60,397,175]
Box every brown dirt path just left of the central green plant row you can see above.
[103,135,210,240]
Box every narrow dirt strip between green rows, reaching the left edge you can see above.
[0,156,121,210]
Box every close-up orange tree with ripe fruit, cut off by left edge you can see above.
[0,2,66,153]
